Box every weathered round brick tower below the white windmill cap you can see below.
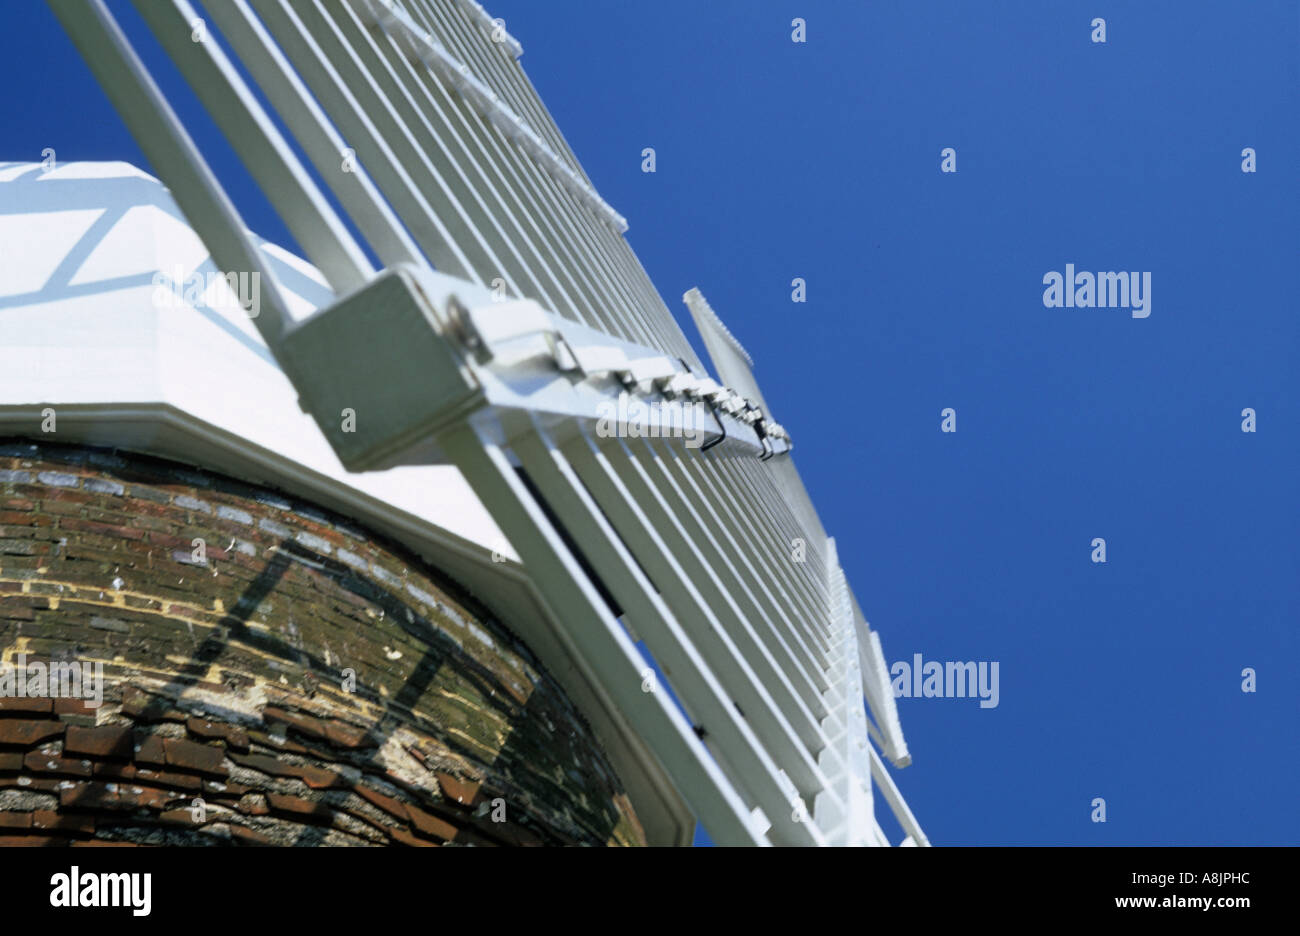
[0,441,645,845]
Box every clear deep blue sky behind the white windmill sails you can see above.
[0,0,1300,845]
